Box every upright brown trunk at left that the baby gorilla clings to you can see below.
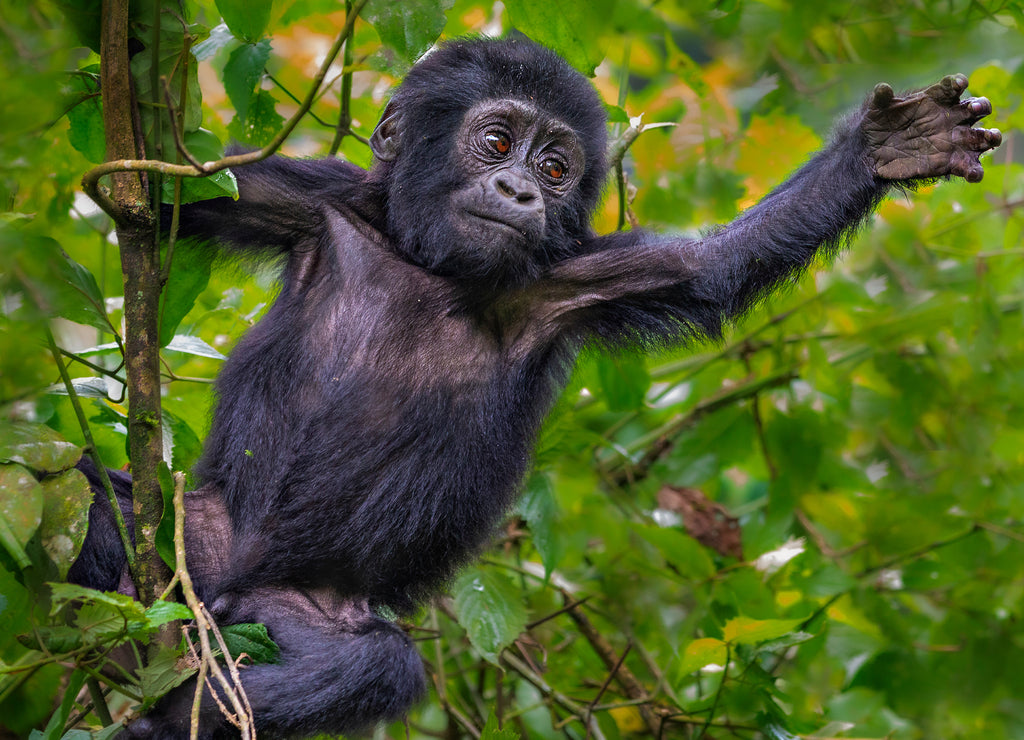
[100,0,169,604]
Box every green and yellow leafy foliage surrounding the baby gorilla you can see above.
[0,0,1024,739]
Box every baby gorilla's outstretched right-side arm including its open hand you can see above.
[535,75,1000,343]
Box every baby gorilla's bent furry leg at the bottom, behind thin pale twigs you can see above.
[128,589,425,740]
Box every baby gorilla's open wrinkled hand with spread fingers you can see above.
[860,75,1002,182]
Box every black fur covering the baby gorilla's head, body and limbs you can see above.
[70,40,958,738]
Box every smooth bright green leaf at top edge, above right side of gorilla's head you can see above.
[505,0,617,77]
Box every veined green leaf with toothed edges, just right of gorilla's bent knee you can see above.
[452,567,526,665]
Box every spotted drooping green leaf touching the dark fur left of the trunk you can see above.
[39,469,92,578]
